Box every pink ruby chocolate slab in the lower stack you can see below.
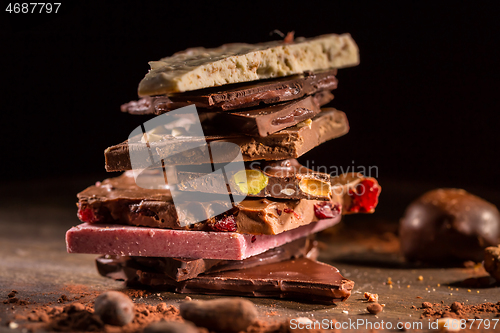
[66,216,340,260]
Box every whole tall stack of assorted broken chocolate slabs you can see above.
[66,34,380,303]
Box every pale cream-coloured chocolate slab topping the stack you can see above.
[138,34,359,97]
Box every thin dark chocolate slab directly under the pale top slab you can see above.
[121,69,338,115]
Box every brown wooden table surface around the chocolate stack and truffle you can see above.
[0,178,500,332]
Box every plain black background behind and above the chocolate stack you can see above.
[0,1,500,189]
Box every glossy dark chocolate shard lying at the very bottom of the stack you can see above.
[97,254,354,304]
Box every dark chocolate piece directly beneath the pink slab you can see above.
[132,237,318,281]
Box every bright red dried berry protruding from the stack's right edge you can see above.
[348,179,380,213]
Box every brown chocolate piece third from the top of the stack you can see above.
[205,91,333,137]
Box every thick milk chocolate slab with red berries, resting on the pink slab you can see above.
[77,170,341,235]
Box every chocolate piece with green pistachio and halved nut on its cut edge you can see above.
[178,159,332,200]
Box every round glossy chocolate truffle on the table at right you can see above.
[399,189,500,263]
